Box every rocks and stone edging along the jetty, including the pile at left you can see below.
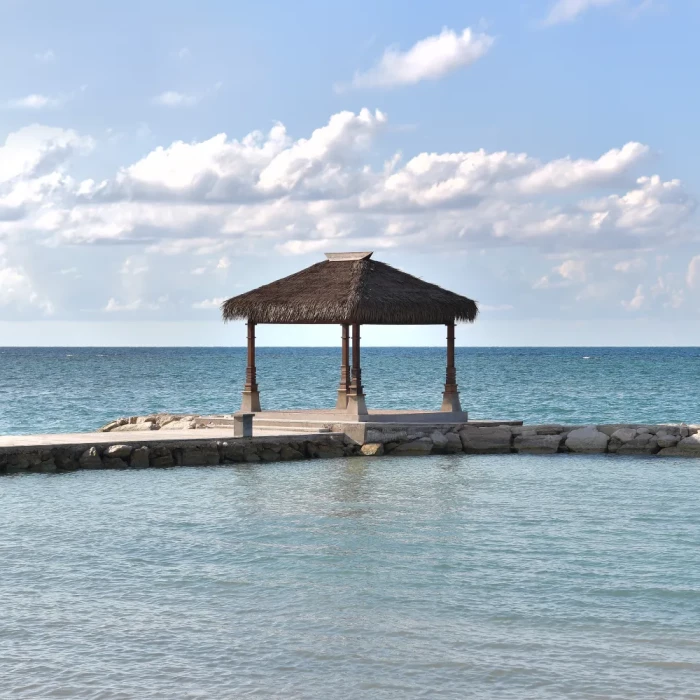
[0,416,700,474]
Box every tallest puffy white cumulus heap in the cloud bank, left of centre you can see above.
[83,109,387,205]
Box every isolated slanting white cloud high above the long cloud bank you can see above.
[344,28,494,90]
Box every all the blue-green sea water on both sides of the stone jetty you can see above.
[0,348,700,700]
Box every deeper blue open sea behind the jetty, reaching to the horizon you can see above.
[0,348,700,434]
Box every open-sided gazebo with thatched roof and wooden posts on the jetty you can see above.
[221,252,479,421]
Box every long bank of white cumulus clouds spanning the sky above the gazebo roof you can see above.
[0,109,697,276]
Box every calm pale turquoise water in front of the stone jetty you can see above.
[0,455,700,700]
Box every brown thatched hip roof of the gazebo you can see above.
[221,253,479,325]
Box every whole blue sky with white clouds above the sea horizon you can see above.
[0,0,700,346]
